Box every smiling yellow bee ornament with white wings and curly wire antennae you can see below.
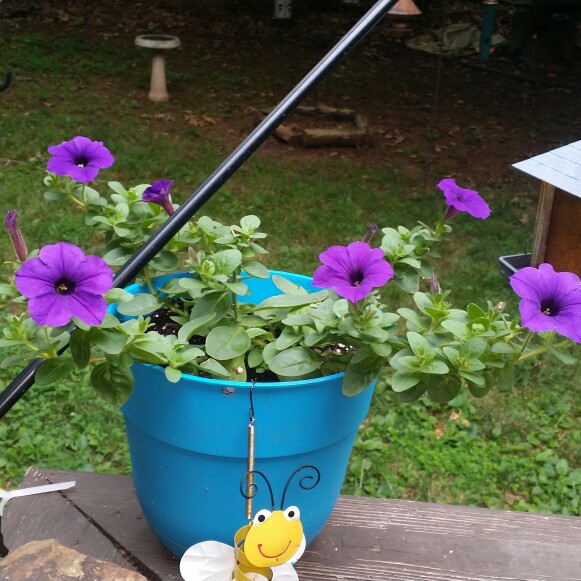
[180,466,320,581]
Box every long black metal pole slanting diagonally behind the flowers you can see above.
[0,0,398,418]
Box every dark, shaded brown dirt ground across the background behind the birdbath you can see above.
[0,0,581,187]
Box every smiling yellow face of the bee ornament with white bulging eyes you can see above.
[244,506,303,567]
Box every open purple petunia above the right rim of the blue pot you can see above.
[313,242,393,303]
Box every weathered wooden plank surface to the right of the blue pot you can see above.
[297,496,581,581]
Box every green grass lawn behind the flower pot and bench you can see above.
[0,17,581,514]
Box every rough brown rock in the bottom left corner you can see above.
[0,539,147,581]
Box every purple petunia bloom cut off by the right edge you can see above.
[510,264,581,343]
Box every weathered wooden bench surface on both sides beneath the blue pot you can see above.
[2,468,581,581]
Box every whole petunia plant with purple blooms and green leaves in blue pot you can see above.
[0,137,581,404]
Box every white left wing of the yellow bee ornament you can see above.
[180,541,234,581]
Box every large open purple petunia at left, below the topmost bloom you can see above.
[14,242,113,327]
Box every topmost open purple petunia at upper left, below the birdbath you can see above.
[46,136,115,183]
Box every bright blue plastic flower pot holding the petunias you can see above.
[116,272,373,557]
